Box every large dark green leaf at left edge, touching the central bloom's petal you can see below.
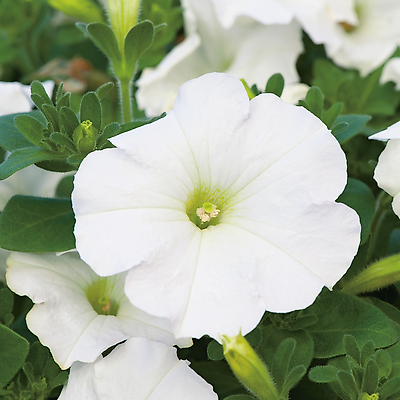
[0,196,75,252]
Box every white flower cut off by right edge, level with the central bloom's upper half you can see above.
[369,121,400,218]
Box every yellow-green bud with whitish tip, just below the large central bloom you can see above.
[221,333,279,400]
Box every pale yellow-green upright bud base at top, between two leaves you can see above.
[107,0,140,54]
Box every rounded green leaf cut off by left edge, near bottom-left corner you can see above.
[0,325,29,389]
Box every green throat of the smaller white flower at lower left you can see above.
[85,277,119,316]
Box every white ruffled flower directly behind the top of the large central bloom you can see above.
[136,0,302,116]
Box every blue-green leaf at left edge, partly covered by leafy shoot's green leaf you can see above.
[0,111,42,152]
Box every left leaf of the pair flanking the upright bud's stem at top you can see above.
[85,22,122,64]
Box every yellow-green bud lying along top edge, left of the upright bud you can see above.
[47,0,104,23]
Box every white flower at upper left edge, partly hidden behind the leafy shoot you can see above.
[0,81,54,116]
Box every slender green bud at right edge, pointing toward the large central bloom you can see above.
[342,254,400,295]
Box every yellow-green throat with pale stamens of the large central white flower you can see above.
[186,189,229,229]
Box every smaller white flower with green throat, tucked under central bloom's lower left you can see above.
[7,253,191,369]
